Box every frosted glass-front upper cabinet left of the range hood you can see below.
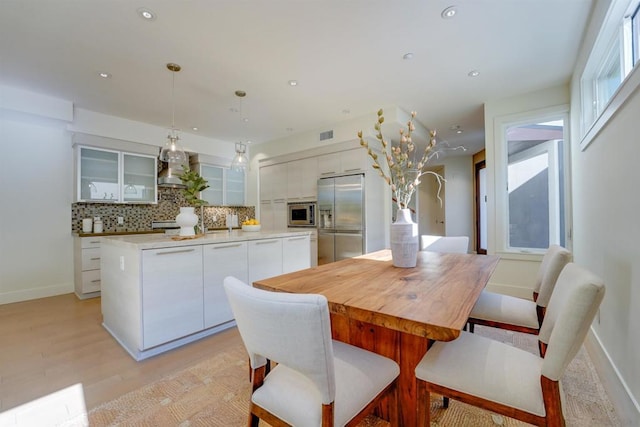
[77,146,157,203]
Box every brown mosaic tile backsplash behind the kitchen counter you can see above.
[71,188,255,233]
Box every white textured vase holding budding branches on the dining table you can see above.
[390,209,418,268]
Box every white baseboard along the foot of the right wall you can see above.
[584,328,640,426]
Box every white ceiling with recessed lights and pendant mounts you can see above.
[0,0,592,157]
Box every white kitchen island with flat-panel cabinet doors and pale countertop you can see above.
[100,230,311,360]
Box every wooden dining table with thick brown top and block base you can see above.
[253,249,498,426]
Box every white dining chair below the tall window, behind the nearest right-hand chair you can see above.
[468,245,572,348]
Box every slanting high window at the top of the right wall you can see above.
[581,0,640,149]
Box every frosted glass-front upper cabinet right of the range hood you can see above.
[200,163,245,206]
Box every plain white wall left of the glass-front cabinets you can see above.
[0,88,73,304]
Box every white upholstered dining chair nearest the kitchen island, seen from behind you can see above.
[224,277,400,427]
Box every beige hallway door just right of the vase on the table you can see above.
[418,167,446,236]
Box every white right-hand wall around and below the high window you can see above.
[571,2,640,426]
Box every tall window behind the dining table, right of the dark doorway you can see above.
[496,107,570,253]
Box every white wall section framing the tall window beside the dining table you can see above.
[484,85,570,299]
